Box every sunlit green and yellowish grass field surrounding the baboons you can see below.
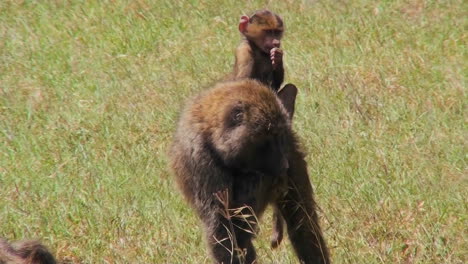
[0,0,468,264]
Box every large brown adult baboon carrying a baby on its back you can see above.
[171,79,330,264]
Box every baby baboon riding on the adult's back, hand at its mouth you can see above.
[230,10,284,92]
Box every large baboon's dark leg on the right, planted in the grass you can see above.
[279,151,330,264]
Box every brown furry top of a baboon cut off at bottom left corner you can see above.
[0,239,56,264]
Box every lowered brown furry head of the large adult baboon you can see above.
[193,80,295,174]
